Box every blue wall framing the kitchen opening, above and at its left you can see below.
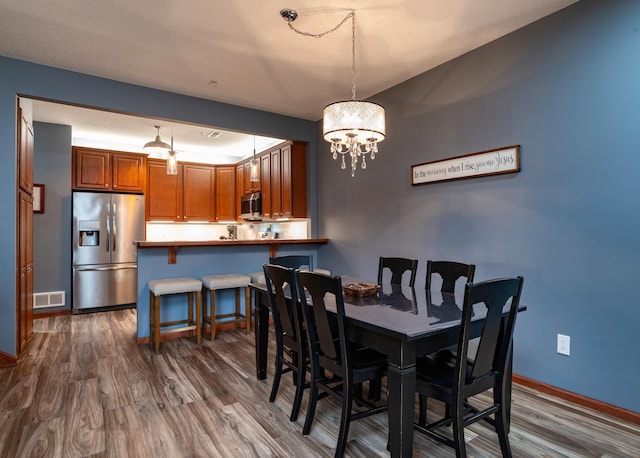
[0,57,316,355]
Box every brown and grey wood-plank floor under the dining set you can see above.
[0,309,640,458]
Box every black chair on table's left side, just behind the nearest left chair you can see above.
[262,264,309,421]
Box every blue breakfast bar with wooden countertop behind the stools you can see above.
[134,238,329,343]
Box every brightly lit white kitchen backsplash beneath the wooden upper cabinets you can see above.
[146,219,311,242]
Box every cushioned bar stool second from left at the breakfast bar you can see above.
[202,274,251,340]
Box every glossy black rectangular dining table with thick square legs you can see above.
[249,277,526,457]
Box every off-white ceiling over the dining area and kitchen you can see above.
[0,0,577,162]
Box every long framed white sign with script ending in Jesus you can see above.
[411,145,520,185]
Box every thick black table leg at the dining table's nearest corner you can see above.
[387,363,416,457]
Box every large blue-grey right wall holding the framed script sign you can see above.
[318,0,640,412]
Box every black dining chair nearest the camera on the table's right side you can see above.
[415,277,523,457]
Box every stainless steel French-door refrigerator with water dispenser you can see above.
[72,192,144,313]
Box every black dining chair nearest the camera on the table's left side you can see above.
[296,271,387,457]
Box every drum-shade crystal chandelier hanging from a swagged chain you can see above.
[280,9,385,177]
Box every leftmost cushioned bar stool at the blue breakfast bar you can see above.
[147,277,202,352]
